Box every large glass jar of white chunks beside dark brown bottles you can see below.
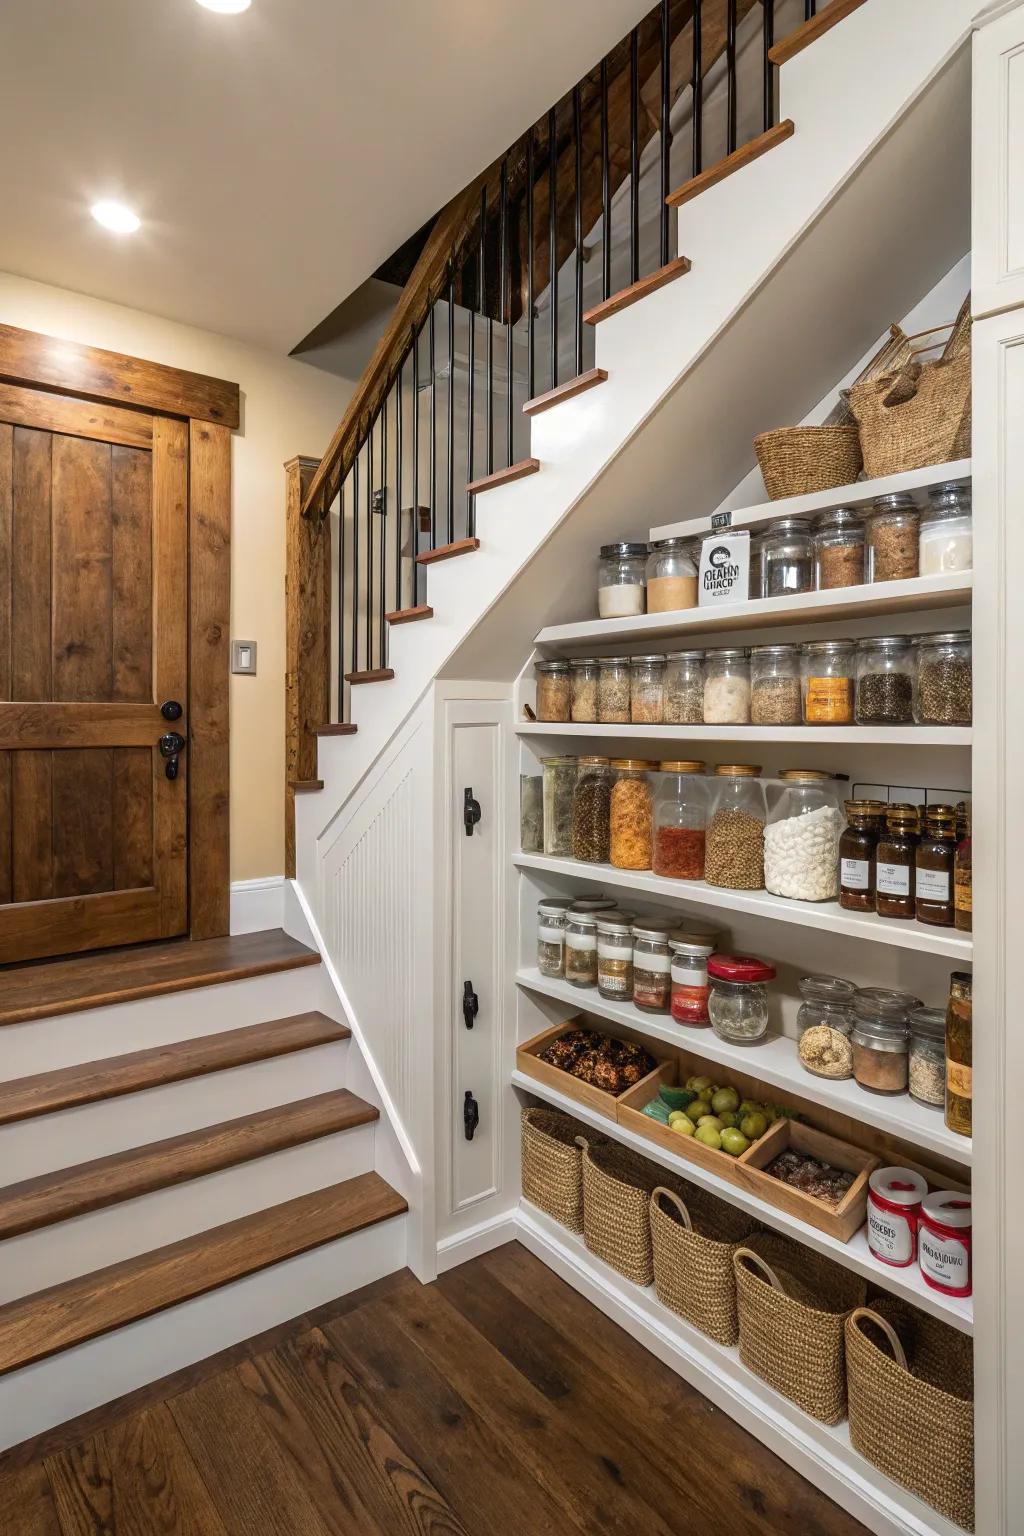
[765,768,843,902]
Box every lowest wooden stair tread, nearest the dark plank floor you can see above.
[0,1174,408,1373]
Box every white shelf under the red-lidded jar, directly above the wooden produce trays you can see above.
[516,968,972,1167]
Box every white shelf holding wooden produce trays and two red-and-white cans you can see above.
[511,1069,975,1335]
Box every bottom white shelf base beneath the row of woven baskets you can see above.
[516,1200,963,1536]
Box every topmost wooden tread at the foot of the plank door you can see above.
[0,928,319,1025]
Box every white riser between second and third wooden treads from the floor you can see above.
[0,1040,348,1179]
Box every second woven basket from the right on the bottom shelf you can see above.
[732,1232,867,1424]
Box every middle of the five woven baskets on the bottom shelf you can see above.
[651,1184,754,1344]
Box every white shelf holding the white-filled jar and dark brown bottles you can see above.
[513,852,973,965]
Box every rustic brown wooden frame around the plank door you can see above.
[0,324,239,938]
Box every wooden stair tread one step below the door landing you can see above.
[0,1012,352,1126]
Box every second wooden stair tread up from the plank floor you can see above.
[0,1087,379,1240]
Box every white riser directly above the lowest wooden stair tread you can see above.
[0,1124,373,1304]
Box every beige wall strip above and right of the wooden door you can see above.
[0,273,352,880]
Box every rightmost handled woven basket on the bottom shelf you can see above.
[846,1296,975,1531]
